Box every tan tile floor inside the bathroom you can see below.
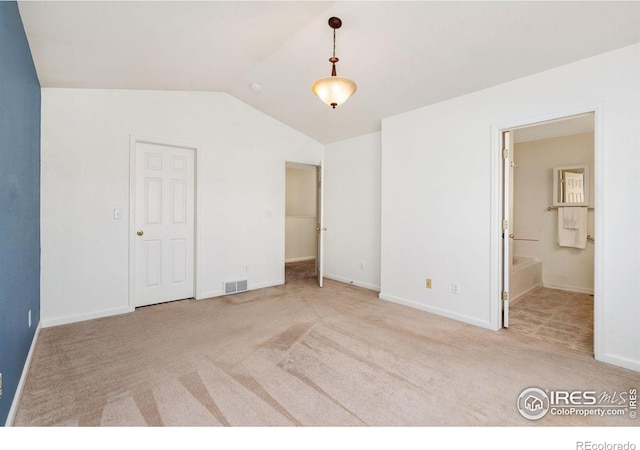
[509,288,593,355]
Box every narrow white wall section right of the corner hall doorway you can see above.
[324,133,380,291]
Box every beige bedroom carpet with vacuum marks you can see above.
[14,280,640,428]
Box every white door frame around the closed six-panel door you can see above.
[129,134,200,310]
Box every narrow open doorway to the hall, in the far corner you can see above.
[284,163,318,283]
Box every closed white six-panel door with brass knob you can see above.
[134,142,195,306]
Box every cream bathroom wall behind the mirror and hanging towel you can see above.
[513,131,595,294]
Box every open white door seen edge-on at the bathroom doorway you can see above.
[501,131,513,328]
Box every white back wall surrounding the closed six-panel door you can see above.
[41,89,323,326]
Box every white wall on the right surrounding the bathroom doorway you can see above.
[380,45,640,370]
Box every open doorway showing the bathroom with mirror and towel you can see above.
[503,113,596,355]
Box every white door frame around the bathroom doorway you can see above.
[490,105,606,360]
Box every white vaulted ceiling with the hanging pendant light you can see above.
[18,0,640,143]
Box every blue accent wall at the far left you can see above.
[0,1,40,425]
